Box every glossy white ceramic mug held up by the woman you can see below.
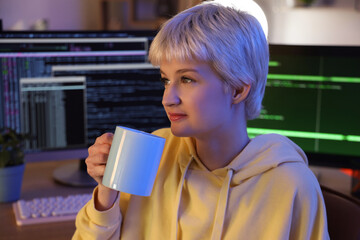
[102,126,165,196]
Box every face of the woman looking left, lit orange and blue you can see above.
[160,60,232,138]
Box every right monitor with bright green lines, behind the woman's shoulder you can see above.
[248,45,360,169]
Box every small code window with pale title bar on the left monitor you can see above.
[16,77,86,149]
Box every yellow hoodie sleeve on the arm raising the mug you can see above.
[72,188,122,240]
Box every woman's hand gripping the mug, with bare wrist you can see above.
[85,133,118,211]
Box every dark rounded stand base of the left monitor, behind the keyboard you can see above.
[53,159,97,187]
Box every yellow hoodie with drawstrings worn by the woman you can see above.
[73,129,329,240]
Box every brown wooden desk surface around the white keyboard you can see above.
[0,160,93,240]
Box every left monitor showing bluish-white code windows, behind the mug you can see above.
[0,31,169,186]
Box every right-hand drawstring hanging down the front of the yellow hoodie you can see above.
[211,169,234,240]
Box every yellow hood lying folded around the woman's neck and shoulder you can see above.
[179,134,308,182]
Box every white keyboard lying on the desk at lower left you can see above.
[13,193,92,226]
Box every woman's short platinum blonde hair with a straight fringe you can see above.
[149,3,269,120]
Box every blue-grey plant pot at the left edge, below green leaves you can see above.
[0,164,25,202]
